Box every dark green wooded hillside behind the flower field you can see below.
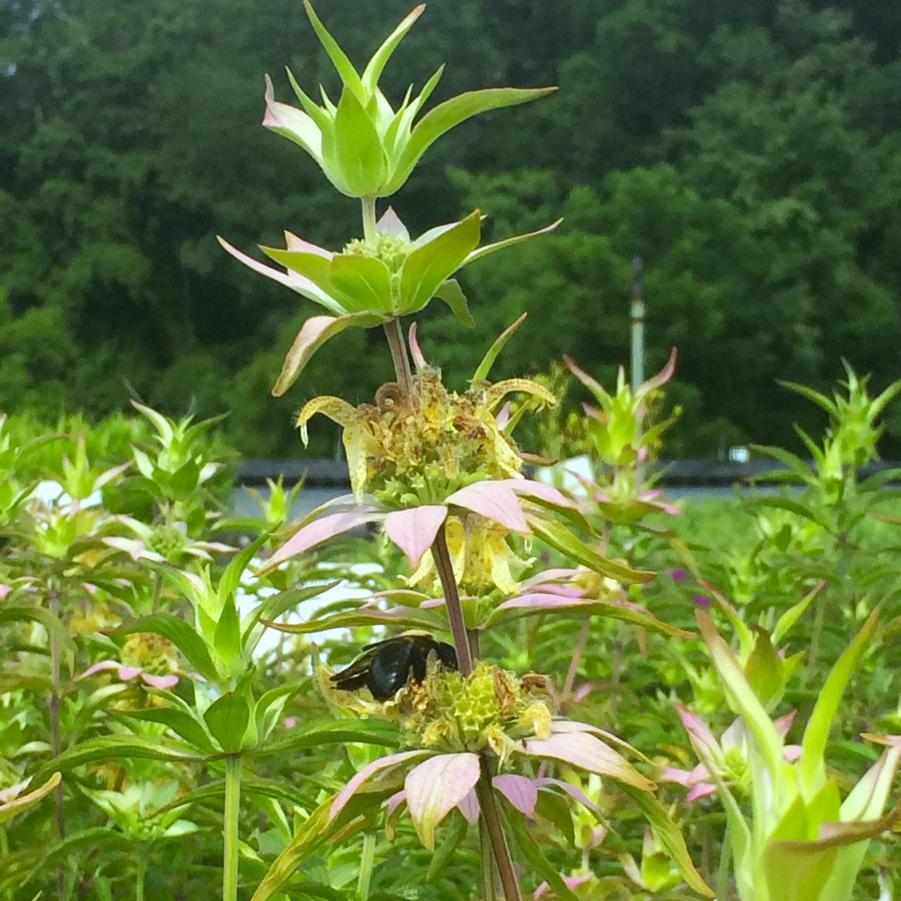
[0,0,901,456]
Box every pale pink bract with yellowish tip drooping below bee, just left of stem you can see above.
[404,753,481,851]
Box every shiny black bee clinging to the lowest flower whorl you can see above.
[331,632,457,701]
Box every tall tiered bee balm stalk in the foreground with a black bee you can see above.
[220,3,711,901]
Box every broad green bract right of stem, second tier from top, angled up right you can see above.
[397,210,482,315]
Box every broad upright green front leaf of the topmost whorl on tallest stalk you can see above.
[322,89,388,197]
